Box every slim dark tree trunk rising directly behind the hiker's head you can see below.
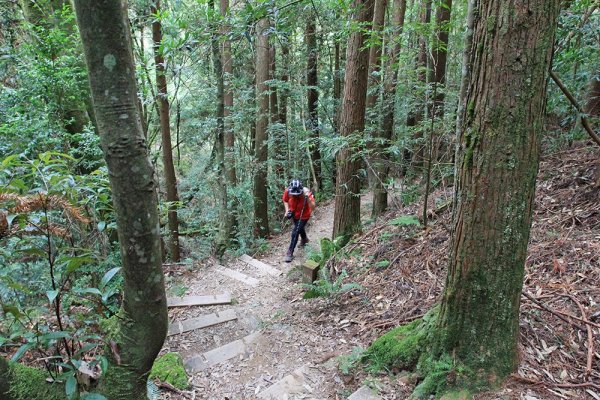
[304,19,323,191]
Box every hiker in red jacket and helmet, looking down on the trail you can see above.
[282,179,315,262]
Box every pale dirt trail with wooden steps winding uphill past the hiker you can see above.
[164,196,371,400]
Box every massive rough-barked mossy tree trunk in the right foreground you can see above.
[432,0,559,385]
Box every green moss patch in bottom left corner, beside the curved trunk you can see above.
[8,363,67,400]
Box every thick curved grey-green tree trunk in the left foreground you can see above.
[75,0,167,400]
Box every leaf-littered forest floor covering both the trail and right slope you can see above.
[162,143,600,400]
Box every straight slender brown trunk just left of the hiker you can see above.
[254,18,269,238]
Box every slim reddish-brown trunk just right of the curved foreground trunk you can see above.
[151,0,180,262]
